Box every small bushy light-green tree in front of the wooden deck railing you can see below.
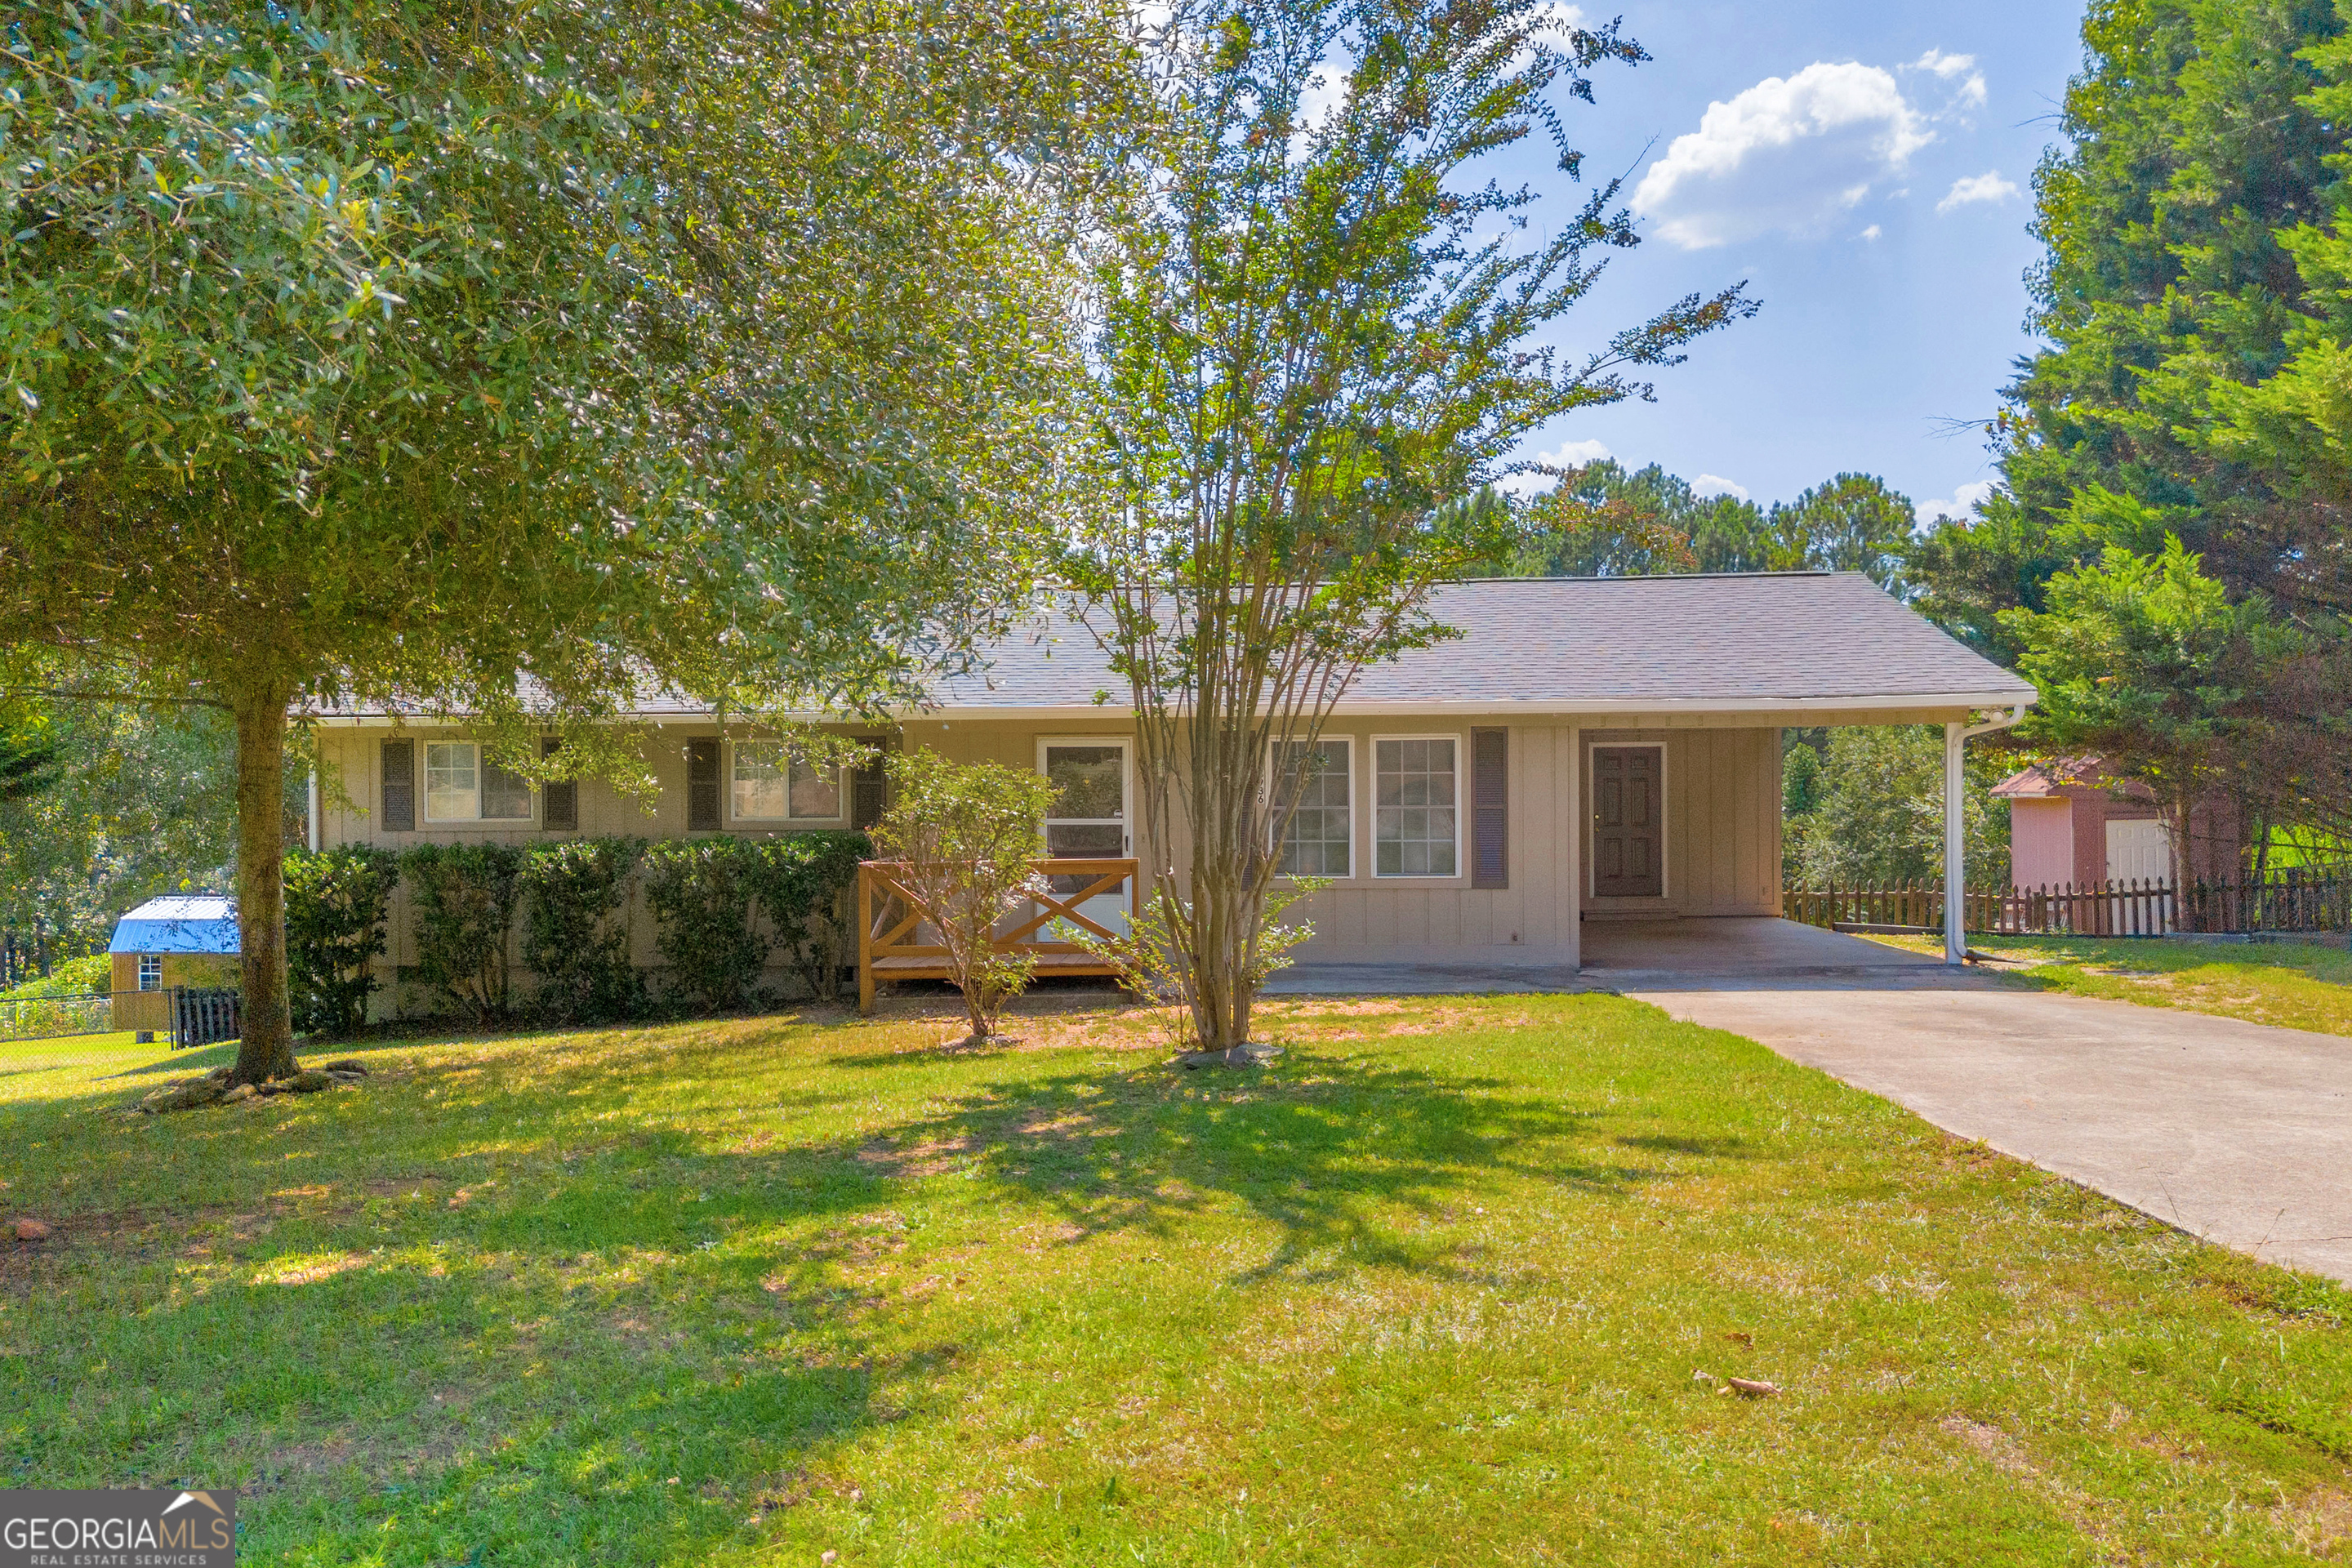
[872,750,1054,1039]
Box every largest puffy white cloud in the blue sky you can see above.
[1633,61,1936,252]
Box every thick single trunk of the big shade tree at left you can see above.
[235,687,296,1084]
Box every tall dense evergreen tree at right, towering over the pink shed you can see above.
[1910,0,2352,846]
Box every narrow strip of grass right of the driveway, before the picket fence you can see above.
[1874,936,2352,1035]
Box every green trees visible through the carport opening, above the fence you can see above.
[1780,724,2013,889]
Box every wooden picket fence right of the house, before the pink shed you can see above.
[1780,872,2352,936]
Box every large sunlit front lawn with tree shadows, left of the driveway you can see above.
[0,997,2352,1568]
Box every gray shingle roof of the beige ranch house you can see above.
[938,571,2034,710]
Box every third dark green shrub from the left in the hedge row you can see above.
[518,840,644,1022]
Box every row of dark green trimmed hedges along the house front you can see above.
[287,832,872,1035]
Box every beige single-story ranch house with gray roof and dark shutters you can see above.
[310,571,2034,1001]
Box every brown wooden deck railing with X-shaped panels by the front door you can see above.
[858,856,1141,1013]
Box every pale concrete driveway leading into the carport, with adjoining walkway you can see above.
[1284,920,2352,1284]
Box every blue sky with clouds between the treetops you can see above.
[1512,0,2082,517]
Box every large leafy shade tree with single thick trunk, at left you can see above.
[0,0,1120,1081]
